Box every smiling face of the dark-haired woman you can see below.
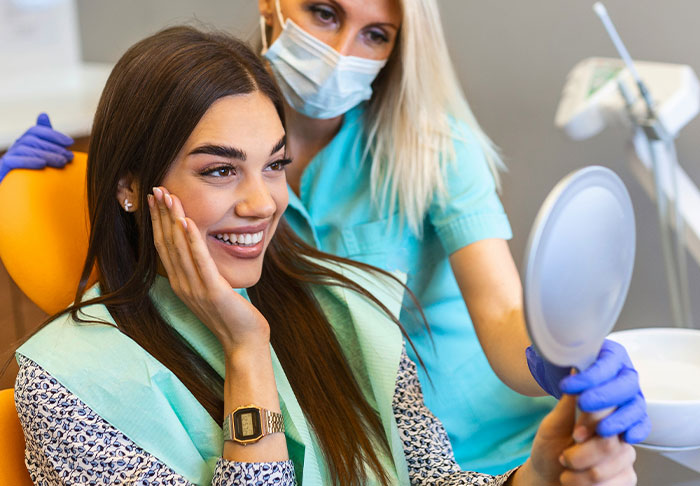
[123,91,291,288]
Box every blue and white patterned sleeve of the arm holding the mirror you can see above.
[392,344,515,486]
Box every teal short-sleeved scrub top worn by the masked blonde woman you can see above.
[285,104,553,474]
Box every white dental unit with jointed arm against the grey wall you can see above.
[555,2,700,327]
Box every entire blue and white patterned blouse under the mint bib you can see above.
[15,347,512,486]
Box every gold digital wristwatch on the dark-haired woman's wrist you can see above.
[223,405,284,445]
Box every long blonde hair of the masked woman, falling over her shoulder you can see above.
[365,0,504,234]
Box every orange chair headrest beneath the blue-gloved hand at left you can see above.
[0,153,96,314]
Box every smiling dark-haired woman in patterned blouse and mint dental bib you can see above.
[9,27,634,486]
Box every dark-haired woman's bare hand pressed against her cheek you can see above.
[148,187,270,356]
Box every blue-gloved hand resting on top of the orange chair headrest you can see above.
[0,113,73,181]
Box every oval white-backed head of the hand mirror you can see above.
[523,166,636,370]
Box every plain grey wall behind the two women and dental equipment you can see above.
[72,0,700,486]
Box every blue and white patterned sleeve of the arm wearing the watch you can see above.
[15,355,296,486]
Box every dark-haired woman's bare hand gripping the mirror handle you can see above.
[509,395,637,486]
